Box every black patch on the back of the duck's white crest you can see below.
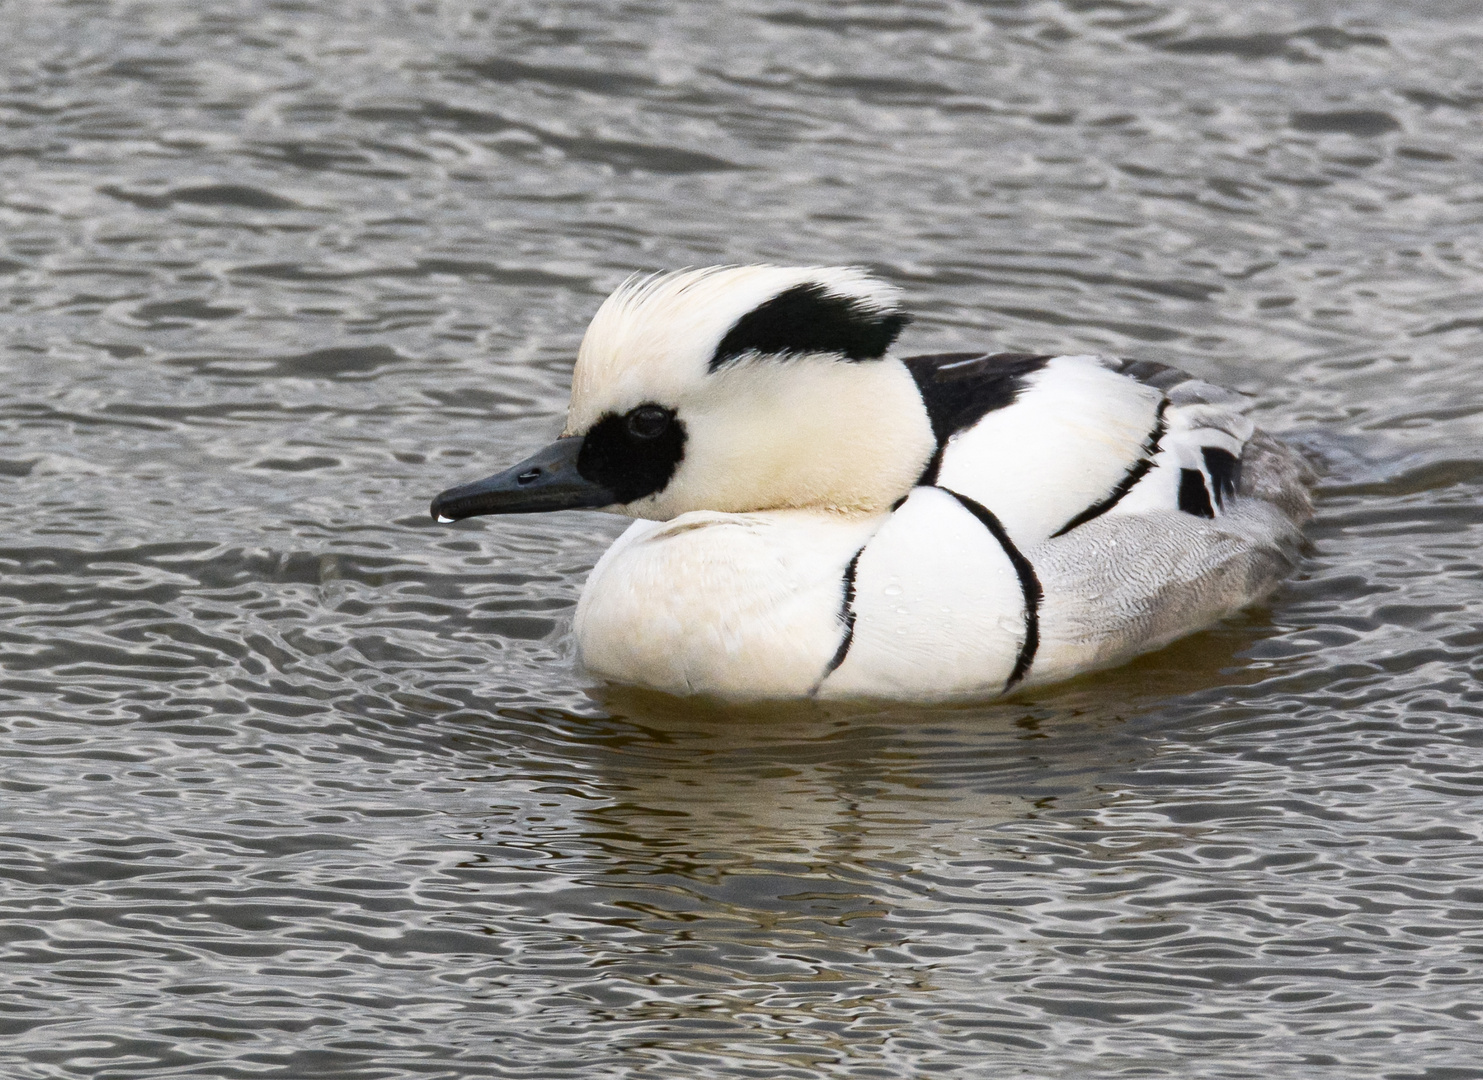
[710,282,911,371]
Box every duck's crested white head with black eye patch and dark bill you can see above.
[432,266,936,521]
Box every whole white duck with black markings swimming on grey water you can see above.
[433,267,1311,702]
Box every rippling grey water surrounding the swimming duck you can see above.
[0,0,1483,1080]
